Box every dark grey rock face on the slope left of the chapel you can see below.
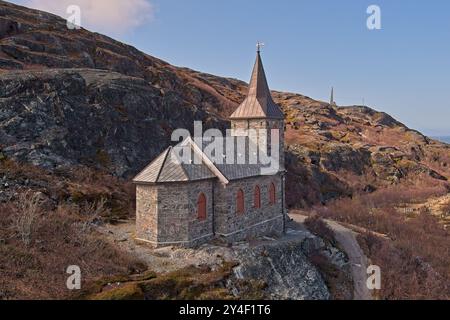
[0,69,222,177]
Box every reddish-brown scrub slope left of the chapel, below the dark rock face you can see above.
[0,160,142,300]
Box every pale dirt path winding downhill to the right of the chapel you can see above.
[289,214,372,300]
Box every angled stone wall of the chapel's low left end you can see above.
[136,180,213,246]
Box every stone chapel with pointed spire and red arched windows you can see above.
[133,49,286,247]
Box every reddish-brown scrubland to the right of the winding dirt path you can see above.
[314,187,450,299]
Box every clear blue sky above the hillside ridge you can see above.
[10,0,450,135]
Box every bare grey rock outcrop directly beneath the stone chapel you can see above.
[92,221,354,300]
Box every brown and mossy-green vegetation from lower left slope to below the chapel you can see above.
[0,160,264,300]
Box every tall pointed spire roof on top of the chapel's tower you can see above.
[230,50,284,120]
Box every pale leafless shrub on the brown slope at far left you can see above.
[12,191,42,246]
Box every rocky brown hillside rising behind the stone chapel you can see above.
[0,1,450,207]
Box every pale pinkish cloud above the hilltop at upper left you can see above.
[25,0,154,35]
